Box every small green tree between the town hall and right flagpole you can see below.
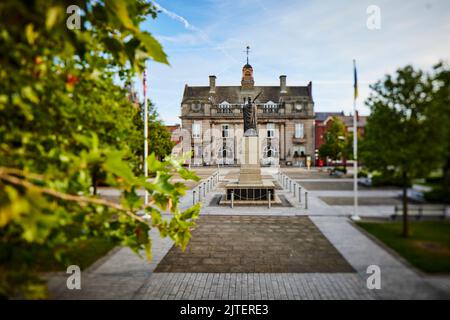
[319,117,347,169]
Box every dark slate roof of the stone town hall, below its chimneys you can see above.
[183,85,311,103]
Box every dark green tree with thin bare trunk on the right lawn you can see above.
[361,66,442,237]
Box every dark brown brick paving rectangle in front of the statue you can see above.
[155,216,354,273]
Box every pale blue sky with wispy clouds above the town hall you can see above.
[135,0,450,124]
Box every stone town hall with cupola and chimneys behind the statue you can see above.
[180,59,314,165]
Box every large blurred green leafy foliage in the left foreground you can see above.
[0,0,200,298]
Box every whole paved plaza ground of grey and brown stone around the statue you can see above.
[49,168,450,300]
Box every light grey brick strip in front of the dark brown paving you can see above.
[137,273,379,300]
